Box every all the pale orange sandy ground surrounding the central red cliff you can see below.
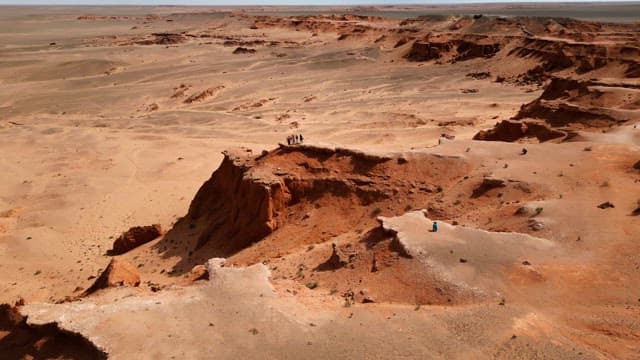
[0,8,640,359]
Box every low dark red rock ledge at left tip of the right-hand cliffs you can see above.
[473,120,567,142]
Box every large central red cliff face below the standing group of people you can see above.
[154,145,470,275]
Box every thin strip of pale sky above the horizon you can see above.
[0,0,634,5]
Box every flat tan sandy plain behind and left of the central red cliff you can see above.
[0,6,536,301]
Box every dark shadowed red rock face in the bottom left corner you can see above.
[0,304,107,360]
